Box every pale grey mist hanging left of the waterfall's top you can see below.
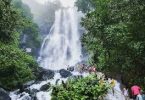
[22,0,60,34]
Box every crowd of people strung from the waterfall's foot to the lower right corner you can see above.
[67,64,145,100]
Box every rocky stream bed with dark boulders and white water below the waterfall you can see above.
[0,68,125,100]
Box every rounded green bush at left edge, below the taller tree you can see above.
[0,44,37,89]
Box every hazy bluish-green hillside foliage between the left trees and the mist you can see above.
[12,0,41,56]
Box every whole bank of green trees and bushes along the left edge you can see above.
[0,0,37,89]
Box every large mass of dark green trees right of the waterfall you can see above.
[77,0,145,86]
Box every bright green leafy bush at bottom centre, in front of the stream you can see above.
[52,75,109,100]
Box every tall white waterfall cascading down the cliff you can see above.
[38,0,81,70]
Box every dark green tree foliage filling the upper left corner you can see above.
[0,0,21,44]
